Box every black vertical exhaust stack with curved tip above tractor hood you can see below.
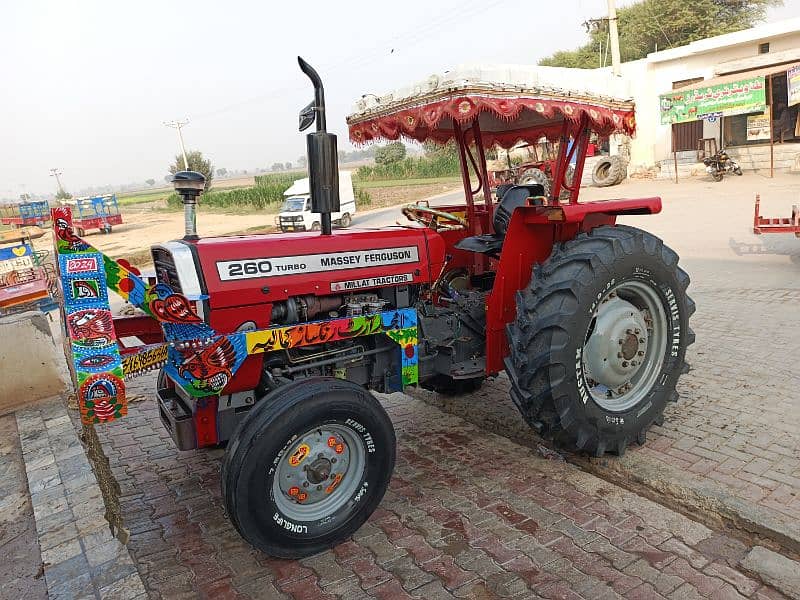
[297,56,339,235]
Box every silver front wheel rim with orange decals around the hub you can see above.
[272,423,366,522]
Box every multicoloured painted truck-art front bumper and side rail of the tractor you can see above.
[52,207,418,423]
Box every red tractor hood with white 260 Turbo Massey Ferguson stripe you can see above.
[173,227,445,310]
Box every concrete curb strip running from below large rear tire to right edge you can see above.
[568,452,800,558]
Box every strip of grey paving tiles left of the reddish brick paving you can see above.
[16,398,147,600]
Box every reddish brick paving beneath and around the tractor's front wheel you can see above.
[90,377,783,600]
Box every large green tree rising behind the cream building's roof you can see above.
[539,0,783,69]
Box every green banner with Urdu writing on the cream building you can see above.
[659,77,767,125]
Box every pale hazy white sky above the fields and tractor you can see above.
[0,0,800,198]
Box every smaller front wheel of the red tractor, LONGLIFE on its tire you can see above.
[222,377,395,558]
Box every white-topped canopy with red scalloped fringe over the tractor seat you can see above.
[347,65,636,148]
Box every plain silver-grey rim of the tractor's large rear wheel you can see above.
[581,281,668,412]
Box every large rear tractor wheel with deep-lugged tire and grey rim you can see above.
[505,225,694,456]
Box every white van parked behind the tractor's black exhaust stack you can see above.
[275,171,356,233]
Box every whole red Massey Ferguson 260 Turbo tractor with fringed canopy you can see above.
[53,59,694,557]
